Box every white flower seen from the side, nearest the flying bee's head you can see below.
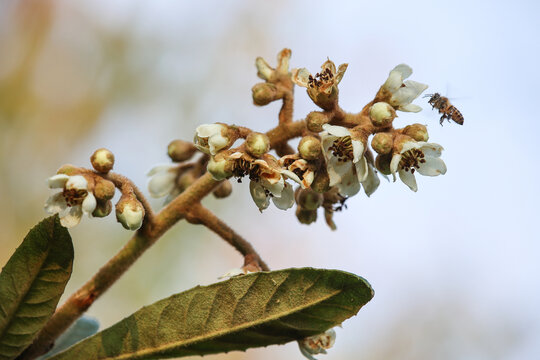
[383,64,428,112]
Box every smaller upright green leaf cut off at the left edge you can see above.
[0,216,73,360]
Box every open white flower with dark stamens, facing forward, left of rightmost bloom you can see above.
[320,124,368,196]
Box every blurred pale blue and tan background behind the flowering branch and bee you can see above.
[0,0,540,360]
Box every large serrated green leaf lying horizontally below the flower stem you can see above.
[51,268,373,360]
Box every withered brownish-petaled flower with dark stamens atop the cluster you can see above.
[292,60,348,95]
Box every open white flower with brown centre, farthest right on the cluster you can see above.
[390,141,446,191]
